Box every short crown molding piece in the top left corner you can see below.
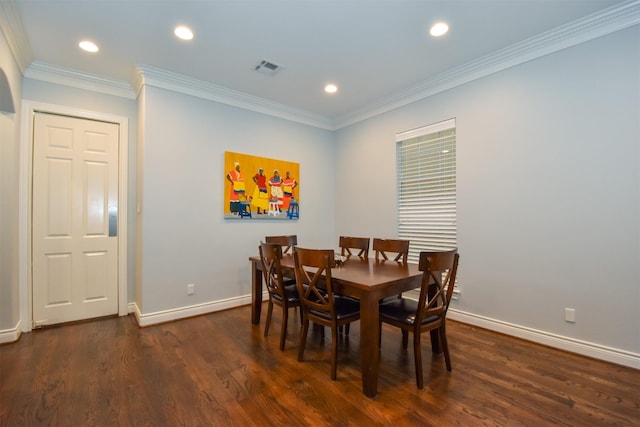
[0,0,33,75]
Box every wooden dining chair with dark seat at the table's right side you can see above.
[379,249,460,389]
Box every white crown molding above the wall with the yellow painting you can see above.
[132,65,333,130]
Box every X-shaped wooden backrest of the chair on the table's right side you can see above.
[415,249,460,325]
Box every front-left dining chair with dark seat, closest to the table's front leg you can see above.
[293,247,360,380]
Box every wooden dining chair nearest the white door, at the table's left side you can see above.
[258,243,302,350]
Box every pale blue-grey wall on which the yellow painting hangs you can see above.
[137,86,337,315]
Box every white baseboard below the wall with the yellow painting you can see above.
[129,294,269,327]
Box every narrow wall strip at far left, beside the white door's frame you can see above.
[0,31,22,332]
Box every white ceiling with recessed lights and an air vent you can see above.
[8,0,632,124]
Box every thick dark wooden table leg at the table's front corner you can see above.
[360,293,380,397]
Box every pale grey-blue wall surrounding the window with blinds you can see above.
[335,26,640,360]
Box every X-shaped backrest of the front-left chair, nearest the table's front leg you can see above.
[293,247,336,317]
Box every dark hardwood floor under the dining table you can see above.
[0,306,640,427]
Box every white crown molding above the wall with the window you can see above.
[334,0,640,129]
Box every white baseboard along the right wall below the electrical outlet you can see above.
[447,308,640,369]
